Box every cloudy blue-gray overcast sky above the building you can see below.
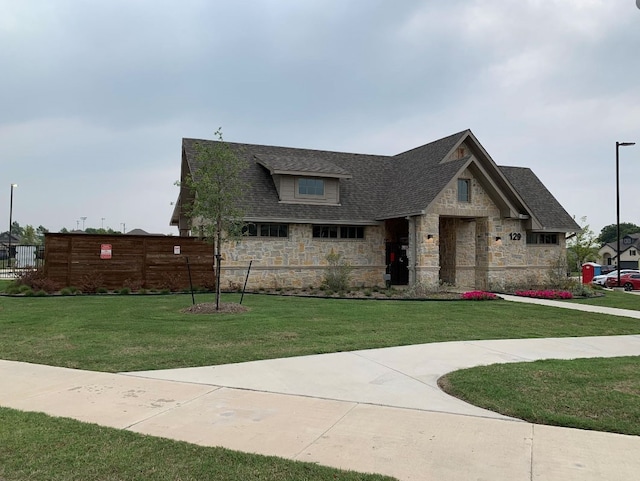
[0,0,640,234]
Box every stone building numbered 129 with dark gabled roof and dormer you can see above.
[171,130,579,289]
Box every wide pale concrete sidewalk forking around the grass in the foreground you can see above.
[0,301,640,481]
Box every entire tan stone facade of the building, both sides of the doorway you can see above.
[205,170,565,290]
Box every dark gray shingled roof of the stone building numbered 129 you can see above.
[183,130,579,231]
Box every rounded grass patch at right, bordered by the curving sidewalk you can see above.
[439,357,640,436]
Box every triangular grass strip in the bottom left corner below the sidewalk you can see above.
[0,408,393,481]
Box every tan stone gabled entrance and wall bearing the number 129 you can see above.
[410,167,565,290]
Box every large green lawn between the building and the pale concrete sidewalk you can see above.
[0,288,640,372]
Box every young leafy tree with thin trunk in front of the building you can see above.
[182,129,247,310]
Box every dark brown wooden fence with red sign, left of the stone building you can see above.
[44,234,215,292]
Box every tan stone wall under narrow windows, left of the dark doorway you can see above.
[222,224,385,289]
